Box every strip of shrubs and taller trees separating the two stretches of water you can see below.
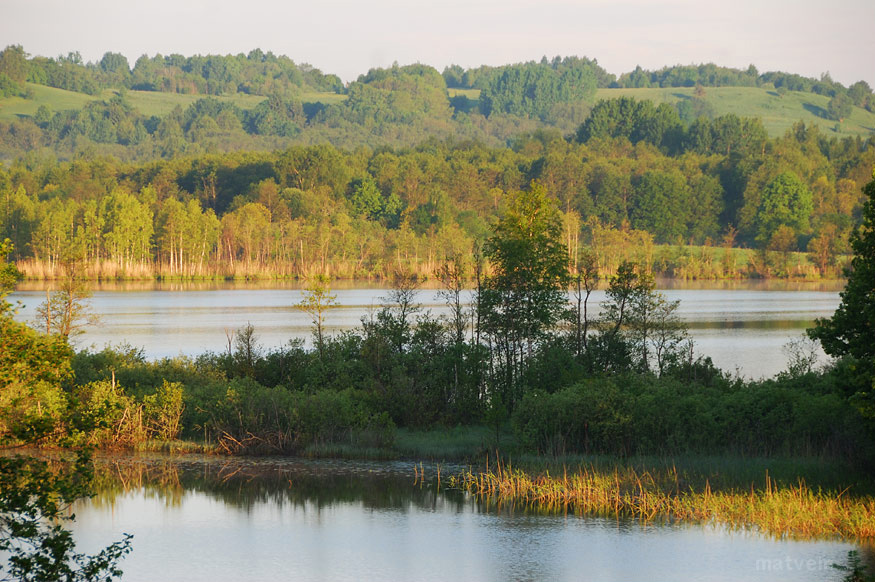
[0,171,875,467]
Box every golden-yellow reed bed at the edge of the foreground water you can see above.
[445,465,875,540]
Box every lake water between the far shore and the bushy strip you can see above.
[12,281,843,378]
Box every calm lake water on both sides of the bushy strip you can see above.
[13,282,872,582]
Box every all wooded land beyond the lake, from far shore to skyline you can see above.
[0,45,875,279]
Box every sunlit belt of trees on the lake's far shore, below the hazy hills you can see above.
[0,122,875,278]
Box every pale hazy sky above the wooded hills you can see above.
[0,0,875,87]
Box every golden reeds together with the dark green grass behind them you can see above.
[445,456,875,540]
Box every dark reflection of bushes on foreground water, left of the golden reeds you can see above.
[93,455,474,512]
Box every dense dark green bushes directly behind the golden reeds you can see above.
[512,374,865,459]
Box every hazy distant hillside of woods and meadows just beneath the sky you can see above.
[0,45,875,161]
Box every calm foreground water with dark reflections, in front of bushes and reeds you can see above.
[65,455,853,582]
